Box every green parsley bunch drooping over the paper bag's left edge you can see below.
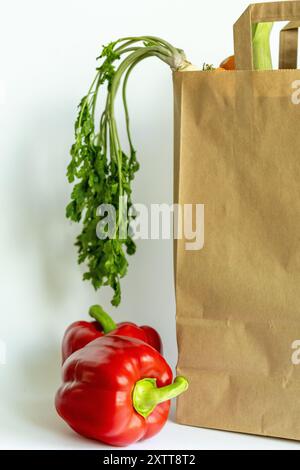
[66,36,188,306]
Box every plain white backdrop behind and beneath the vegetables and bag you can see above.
[0,0,298,449]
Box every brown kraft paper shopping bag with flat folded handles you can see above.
[174,1,300,440]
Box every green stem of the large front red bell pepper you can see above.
[132,377,189,419]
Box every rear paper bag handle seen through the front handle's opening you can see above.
[279,21,300,69]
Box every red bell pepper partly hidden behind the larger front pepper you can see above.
[62,305,163,363]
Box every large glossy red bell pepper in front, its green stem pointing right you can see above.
[55,335,188,447]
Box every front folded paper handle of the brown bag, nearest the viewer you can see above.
[233,0,300,70]
